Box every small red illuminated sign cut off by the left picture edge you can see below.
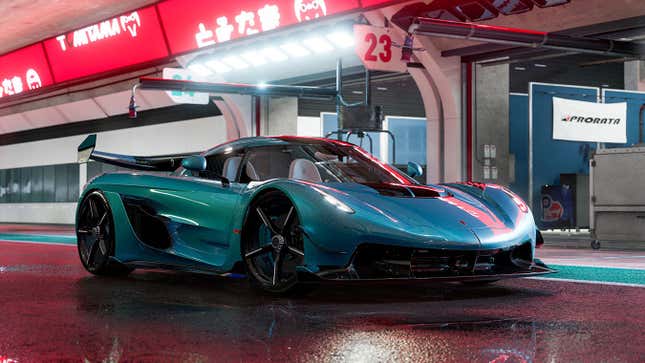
[0,43,54,98]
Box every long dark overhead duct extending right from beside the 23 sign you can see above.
[408,18,641,57]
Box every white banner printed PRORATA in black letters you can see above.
[553,97,627,144]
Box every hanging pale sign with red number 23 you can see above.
[354,25,407,72]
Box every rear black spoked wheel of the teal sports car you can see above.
[76,190,132,276]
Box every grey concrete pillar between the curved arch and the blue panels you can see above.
[473,64,513,185]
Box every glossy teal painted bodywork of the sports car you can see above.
[76,138,535,273]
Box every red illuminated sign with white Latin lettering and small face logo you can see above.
[44,6,168,82]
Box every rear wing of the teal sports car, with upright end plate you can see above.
[78,134,195,171]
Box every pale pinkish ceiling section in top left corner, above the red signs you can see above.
[0,0,156,54]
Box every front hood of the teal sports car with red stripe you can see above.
[326,183,523,243]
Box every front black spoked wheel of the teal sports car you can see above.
[241,190,308,294]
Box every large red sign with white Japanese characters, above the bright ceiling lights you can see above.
[158,0,359,54]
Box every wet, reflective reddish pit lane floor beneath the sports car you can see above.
[0,227,645,363]
